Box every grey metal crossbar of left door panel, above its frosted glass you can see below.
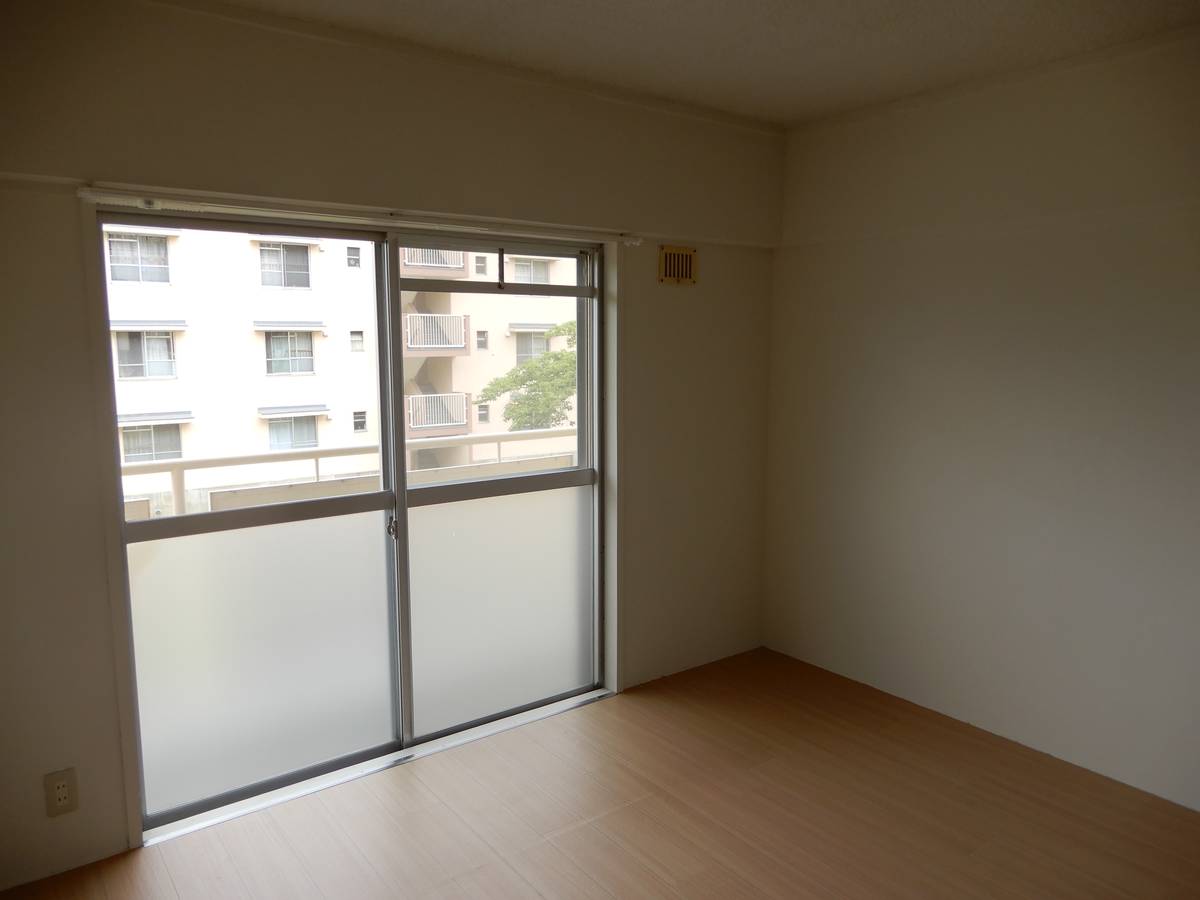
[125,491,396,544]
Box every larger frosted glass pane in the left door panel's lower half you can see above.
[128,512,395,814]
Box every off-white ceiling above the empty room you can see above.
[223,0,1200,124]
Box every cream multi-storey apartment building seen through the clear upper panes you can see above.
[104,224,576,518]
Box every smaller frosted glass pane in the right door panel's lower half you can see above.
[408,487,593,734]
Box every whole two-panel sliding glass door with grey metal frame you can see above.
[101,214,599,827]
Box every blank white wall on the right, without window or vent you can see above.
[766,31,1200,809]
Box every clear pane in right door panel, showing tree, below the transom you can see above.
[401,290,578,486]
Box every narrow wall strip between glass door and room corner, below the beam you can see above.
[618,244,772,684]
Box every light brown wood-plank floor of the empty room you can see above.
[6,650,1200,900]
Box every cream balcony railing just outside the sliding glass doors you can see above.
[121,427,576,516]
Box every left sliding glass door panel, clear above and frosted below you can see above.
[102,216,401,826]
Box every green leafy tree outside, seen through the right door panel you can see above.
[478,322,576,431]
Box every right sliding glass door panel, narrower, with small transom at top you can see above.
[398,239,596,738]
